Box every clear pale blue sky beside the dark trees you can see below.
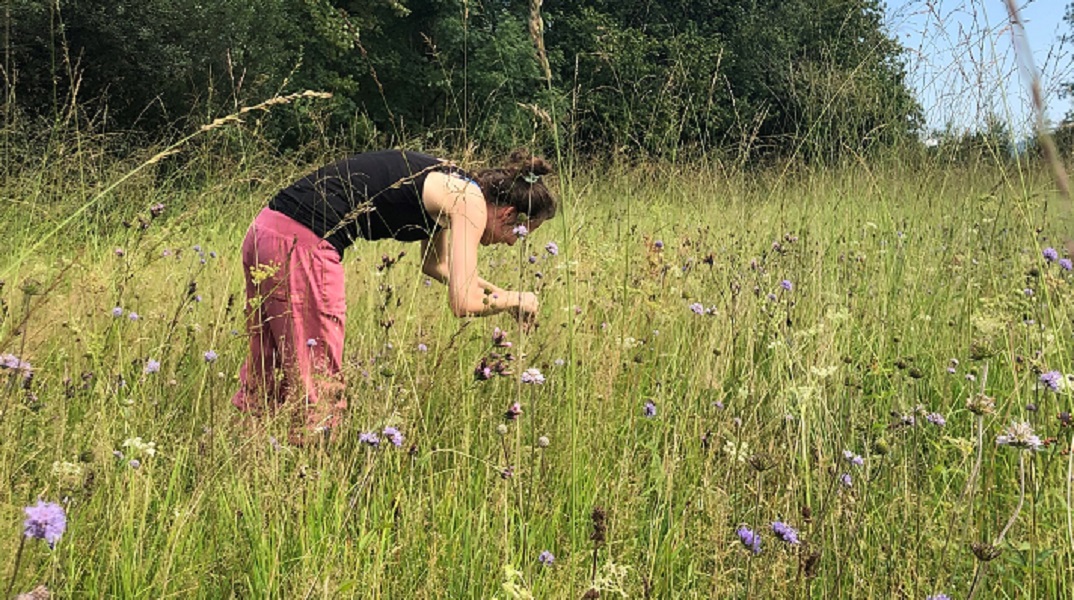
[886,0,1074,133]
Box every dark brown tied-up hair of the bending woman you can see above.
[475,149,556,220]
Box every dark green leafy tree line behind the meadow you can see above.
[2,0,921,159]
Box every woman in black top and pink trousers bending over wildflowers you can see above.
[232,150,556,430]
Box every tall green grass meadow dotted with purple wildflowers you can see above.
[0,144,1074,599]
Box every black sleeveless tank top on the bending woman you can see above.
[269,150,466,255]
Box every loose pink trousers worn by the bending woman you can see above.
[231,208,347,429]
